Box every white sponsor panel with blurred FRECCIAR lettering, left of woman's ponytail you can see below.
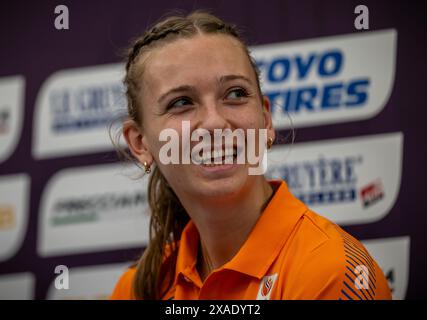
[37,164,149,256]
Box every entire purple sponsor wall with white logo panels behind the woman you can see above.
[0,0,427,299]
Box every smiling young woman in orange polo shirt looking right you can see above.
[111,12,390,300]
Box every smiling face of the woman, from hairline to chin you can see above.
[137,35,274,197]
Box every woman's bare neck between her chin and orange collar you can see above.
[181,176,273,281]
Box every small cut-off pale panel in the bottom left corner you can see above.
[0,272,35,300]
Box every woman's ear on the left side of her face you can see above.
[123,120,153,165]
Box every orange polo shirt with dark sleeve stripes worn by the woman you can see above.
[111,181,391,300]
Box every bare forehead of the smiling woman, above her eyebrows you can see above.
[143,35,255,93]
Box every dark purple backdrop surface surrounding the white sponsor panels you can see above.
[0,0,427,299]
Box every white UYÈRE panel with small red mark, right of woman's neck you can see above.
[267,133,403,225]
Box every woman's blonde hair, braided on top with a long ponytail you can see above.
[123,11,261,299]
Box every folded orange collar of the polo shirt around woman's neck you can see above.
[175,180,307,286]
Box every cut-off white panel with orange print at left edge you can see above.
[0,174,30,262]
